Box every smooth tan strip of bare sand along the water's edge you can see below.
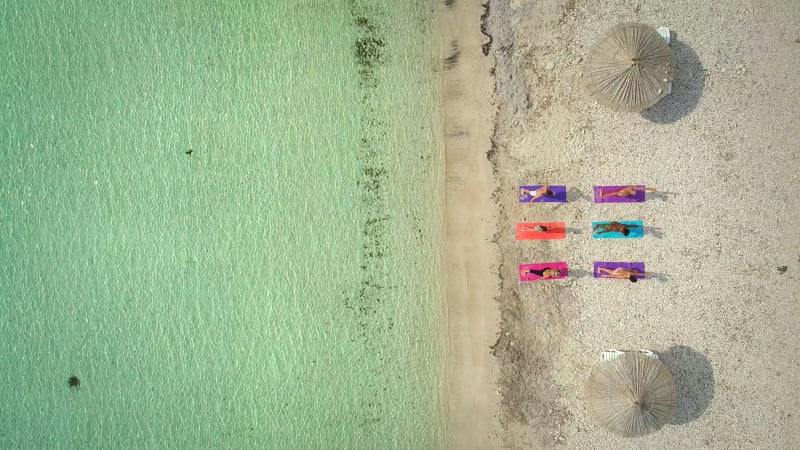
[438,2,502,449]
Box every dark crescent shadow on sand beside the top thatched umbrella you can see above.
[640,32,706,124]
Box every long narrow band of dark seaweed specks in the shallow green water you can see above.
[344,0,400,435]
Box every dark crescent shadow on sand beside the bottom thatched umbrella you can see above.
[659,345,714,425]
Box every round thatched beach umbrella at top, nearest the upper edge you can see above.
[583,23,675,112]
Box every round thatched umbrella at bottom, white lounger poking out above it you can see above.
[586,352,676,437]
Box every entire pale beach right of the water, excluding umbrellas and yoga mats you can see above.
[440,0,800,449]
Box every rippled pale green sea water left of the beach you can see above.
[0,0,444,448]
